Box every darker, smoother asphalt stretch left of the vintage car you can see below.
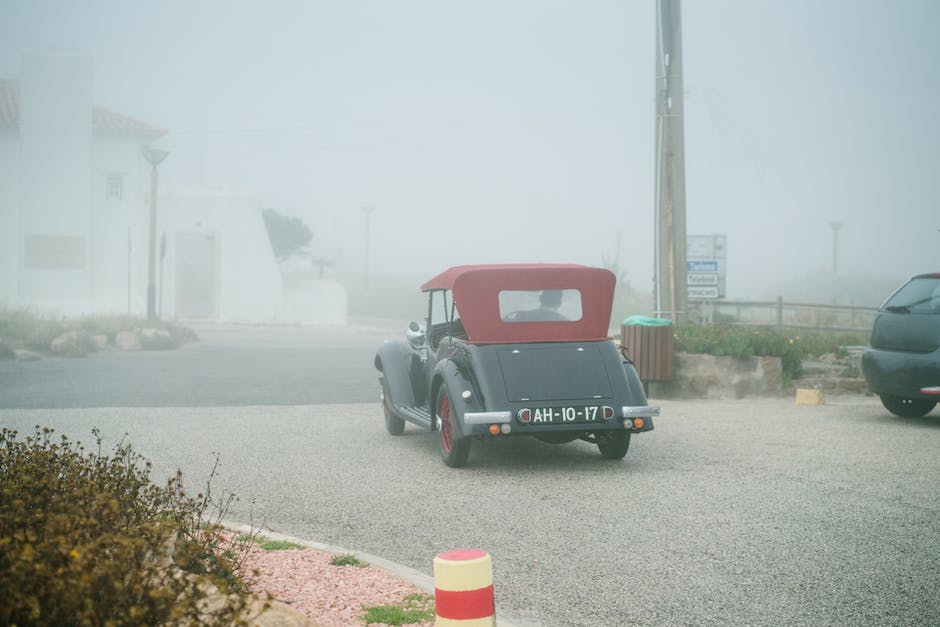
[0,321,406,409]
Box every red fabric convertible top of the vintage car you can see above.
[421,264,617,344]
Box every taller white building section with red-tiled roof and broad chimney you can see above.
[0,54,165,313]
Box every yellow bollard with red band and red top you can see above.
[434,549,496,627]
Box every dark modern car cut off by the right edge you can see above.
[862,273,940,417]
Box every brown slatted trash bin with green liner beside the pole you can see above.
[620,316,675,383]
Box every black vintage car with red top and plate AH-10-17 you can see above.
[375,264,659,467]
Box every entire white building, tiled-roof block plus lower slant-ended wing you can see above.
[0,53,346,324]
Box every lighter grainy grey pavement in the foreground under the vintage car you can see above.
[0,326,940,626]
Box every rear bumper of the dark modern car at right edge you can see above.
[862,347,940,400]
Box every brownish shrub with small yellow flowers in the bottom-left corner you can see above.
[0,427,253,625]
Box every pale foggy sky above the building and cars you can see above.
[0,0,940,303]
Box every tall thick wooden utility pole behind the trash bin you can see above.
[654,0,688,324]
